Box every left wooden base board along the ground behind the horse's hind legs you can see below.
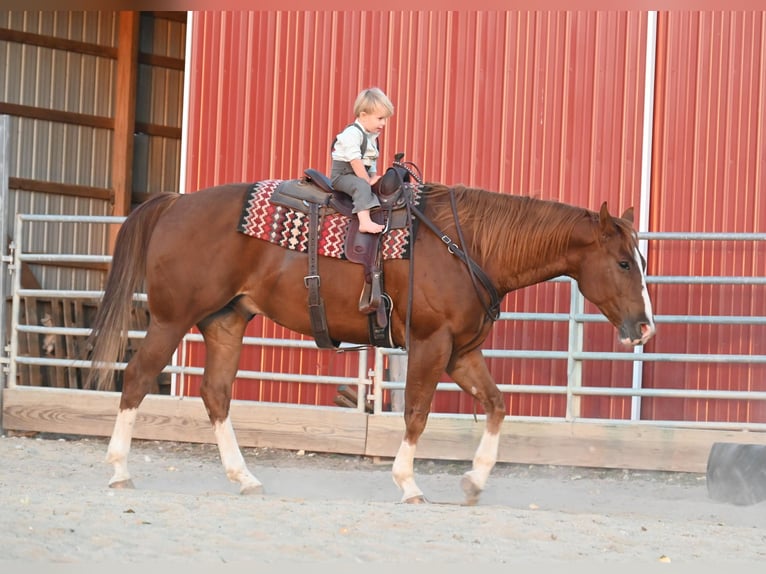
[2,386,367,454]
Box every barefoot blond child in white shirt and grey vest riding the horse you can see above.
[330,88,394,233]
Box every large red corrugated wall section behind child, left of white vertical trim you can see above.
[186,11,646,416]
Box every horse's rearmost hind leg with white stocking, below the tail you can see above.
[106,324,185,488]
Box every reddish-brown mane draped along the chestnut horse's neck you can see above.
[423,184,600,269]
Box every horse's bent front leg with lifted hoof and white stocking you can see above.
[448,349,505,505]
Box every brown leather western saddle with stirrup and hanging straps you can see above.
[270,153,420,348]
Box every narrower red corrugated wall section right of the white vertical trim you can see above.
[642,12,766,422]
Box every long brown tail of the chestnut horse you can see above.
[85,193,180,391]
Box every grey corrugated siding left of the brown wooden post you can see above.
[0,11,116,289]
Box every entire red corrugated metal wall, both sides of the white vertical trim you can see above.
[186,11,766,424]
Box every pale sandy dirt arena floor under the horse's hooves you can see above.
[0,435,766,572]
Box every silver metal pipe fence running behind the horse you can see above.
[2,214,766,430]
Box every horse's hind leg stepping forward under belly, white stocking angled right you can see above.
[198,307,263,494]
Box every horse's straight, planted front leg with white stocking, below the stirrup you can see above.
[392,342,449,504]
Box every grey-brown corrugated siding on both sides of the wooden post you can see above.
[0,11,186,289]
